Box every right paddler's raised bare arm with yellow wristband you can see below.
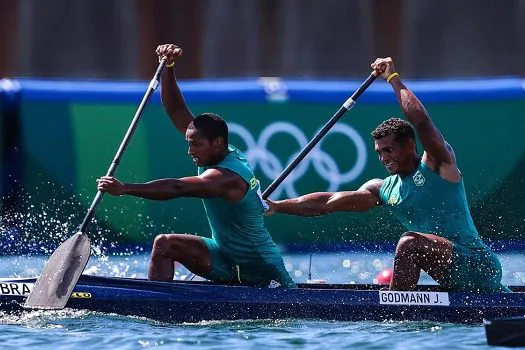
[371,57,460,181]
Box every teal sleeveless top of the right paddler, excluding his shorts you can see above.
[379,161,488,248]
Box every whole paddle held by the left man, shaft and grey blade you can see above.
[24,59,166,309]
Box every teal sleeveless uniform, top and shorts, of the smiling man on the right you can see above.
[379,161,510,292]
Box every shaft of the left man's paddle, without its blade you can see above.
[79,59,166,234]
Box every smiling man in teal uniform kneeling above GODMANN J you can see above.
[267,58,509,292]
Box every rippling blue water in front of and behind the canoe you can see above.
[0,252,525,350]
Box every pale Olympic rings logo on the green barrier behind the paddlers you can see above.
[228,122,367,198]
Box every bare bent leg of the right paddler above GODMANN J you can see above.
[390,232,452,290]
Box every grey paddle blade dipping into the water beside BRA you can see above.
[24,232,91,309]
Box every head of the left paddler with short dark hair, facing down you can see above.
[186,113,228,166]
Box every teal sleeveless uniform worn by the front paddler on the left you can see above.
[198,145,295,287]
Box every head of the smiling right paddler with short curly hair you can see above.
[372,118,418,175]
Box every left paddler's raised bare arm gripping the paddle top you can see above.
[156,44,194,133]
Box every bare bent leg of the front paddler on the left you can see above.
[148,234,211,281]
